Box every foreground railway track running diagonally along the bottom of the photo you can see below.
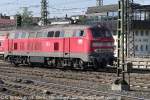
[2,76,144,100]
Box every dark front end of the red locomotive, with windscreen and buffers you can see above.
[90,26,114,67]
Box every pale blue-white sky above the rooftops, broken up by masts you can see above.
[0,0,150,17]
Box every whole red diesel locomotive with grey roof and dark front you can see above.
[4,25,114,69]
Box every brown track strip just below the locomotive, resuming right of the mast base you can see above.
[0,66,150,90]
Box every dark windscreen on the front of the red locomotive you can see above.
[91,27,112,38]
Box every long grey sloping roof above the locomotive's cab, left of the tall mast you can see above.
[86,4,118,14]
